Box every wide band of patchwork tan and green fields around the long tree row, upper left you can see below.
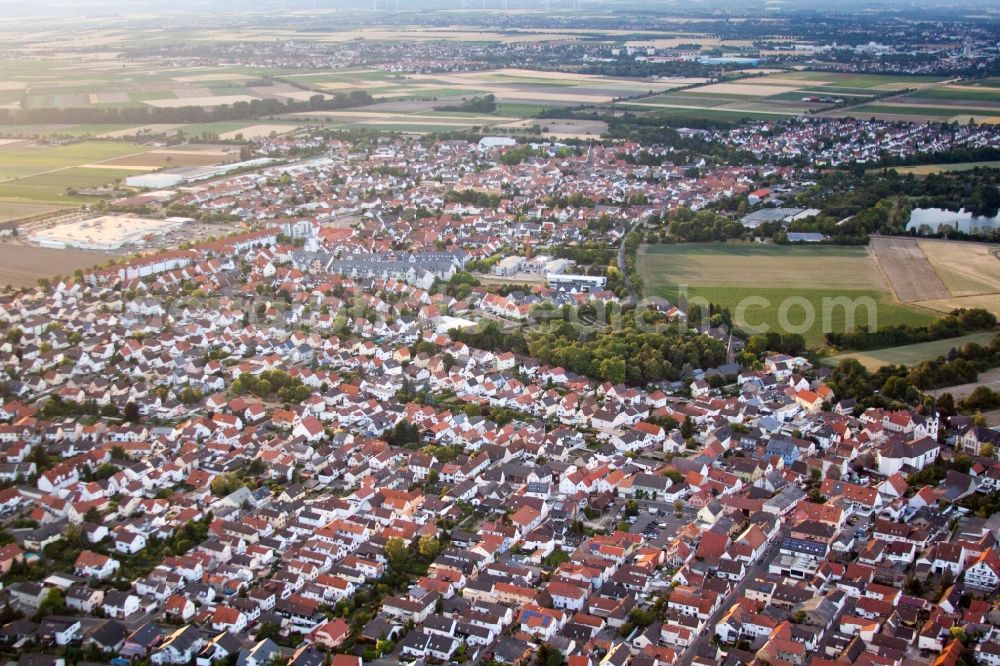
[0,54,704,140]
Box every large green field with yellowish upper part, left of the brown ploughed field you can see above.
[639,243,934,346]
